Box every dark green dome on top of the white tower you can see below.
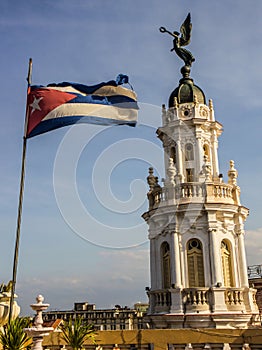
[168,78,206,108]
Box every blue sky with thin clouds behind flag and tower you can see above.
[0,0,262,313]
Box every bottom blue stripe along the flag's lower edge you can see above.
[27,116,136,138]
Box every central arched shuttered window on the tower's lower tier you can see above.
[187,239,205,287]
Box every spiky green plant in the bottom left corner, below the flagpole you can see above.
[0,317,31,350]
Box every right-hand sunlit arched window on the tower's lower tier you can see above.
[221,240,234,287]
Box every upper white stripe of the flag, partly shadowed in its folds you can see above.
[47,85,137,101]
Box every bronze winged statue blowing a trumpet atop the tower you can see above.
[159,13,195,67]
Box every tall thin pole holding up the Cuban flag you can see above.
[9,58,32,323]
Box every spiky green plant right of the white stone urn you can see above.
[60,317,96,350]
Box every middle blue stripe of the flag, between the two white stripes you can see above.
[66,95,138,109]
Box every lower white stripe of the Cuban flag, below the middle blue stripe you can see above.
[42,103,138,121]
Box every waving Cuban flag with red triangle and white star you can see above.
[25,74,138,138]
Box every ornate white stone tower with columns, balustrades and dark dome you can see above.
[143,22,258,328]
